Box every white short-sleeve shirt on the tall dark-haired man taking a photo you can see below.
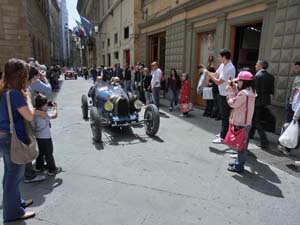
[216,61,235,96]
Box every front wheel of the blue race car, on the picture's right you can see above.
[144,104,160,136]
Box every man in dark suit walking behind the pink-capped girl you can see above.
[249,60,274,148]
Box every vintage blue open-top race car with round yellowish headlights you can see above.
[81,82,160,143]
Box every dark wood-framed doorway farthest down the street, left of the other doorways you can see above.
[149,32,166,71]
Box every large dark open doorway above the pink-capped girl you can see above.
[231,22,262,74]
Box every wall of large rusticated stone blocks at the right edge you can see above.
[270,0,300,106]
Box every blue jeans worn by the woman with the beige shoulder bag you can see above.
[0,134,25,221]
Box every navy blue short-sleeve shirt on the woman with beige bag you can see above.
[0,89,27,143]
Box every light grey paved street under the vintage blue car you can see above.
[0,78,300,225]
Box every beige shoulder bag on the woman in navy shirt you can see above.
[6,91,39,164]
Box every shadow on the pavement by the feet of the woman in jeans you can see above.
[20,176,63,206]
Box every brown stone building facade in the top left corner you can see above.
[0,0,50,66]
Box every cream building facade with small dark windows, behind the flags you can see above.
[77,0,142,66]
